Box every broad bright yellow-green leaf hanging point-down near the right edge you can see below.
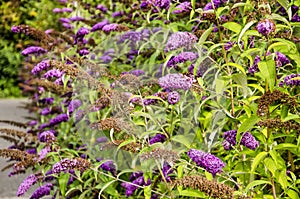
[257,59,276,92]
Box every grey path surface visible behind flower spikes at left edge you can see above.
[0,99,37,199]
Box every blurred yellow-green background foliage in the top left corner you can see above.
[0,0,59,98]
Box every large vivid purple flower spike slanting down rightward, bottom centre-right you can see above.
[187,149,225,176]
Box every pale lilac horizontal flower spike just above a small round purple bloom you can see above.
[158,74,193,90]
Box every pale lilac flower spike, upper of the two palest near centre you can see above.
[164,32,198,52]
